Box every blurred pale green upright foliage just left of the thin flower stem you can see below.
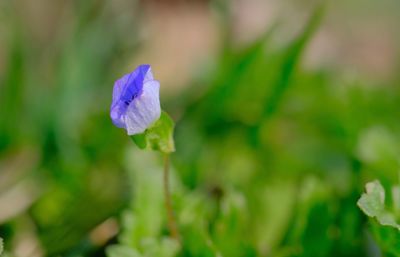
[107,151,180,257]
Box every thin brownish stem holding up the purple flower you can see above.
[164,154,180,240]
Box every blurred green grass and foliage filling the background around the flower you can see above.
[0,0,400,257]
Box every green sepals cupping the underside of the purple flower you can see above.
[131,111,175,153]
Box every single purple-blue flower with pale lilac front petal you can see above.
[110,64,161,135]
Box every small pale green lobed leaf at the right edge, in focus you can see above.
[357,180,400,230]
